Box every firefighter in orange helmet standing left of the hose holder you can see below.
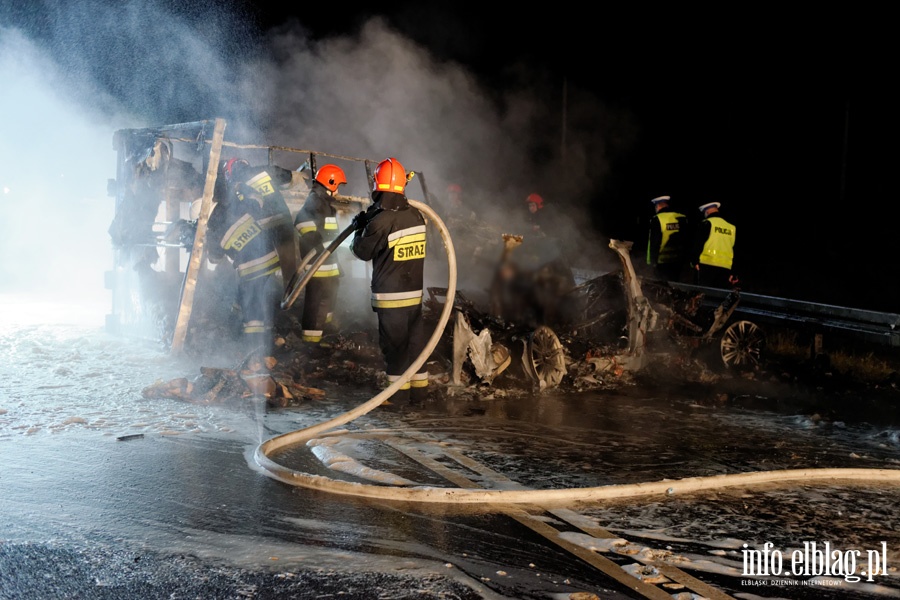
[294,164,347,344]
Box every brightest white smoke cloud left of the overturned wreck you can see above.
[0,29,121,308]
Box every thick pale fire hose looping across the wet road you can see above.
[254,200,900,504]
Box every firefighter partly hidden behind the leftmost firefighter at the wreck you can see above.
[224,158,302,285]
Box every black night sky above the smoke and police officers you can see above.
[0,0,900,312]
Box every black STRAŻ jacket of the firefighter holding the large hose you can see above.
[350,192,426,310]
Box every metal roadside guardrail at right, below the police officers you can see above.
[669,281,900,348]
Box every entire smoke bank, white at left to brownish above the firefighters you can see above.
[0,0,637,330]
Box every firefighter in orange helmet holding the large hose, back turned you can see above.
[350,158,428,403]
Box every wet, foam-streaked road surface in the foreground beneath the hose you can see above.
[0,312,900,598]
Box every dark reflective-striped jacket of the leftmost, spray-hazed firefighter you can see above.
[207,197,280,282]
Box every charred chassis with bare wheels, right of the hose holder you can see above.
[425,234,766,391]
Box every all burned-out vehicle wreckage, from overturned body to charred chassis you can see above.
[107,119,888,406]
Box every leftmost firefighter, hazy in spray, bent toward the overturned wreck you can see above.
[207,159,284,357]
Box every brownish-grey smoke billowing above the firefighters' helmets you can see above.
[242,17,635,282]
